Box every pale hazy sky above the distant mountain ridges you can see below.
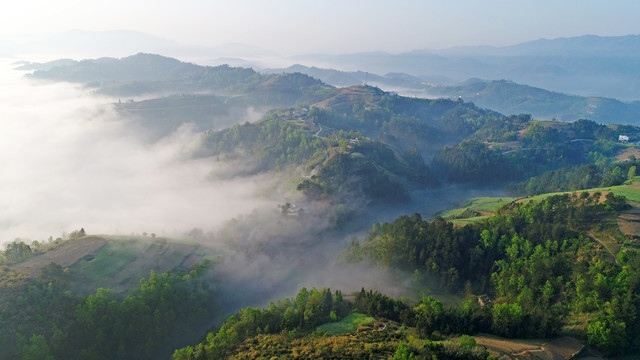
[0,0,640,55]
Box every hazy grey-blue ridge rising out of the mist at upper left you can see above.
[19,53,338,102]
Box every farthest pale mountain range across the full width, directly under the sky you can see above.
[7,30,640,101]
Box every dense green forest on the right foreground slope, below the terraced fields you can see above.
[345,192,640,353]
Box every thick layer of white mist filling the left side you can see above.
[0,60,274,244]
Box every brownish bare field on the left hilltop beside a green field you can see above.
[12,236,107,276]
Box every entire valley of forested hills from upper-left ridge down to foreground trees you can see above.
[0,50,640,360]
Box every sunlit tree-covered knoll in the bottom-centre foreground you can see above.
[172,288,489,360]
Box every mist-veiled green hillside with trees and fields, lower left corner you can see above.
[0,236,215,359]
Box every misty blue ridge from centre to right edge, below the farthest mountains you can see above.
[265,65,640,124]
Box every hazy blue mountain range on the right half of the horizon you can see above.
[293,35,640,101]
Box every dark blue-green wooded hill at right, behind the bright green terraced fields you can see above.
[431,119,638,184]
